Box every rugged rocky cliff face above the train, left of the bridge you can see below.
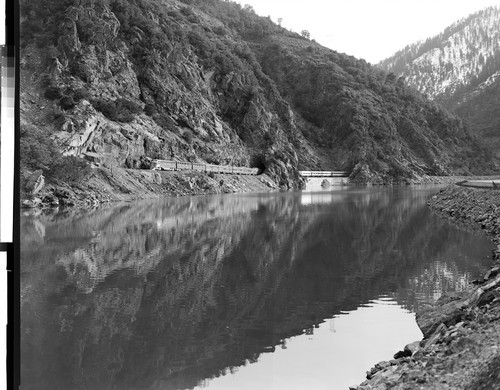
[23,1,308,187]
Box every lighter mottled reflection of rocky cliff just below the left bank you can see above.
[22,196,272,292]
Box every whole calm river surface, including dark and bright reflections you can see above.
[21,187,492,390]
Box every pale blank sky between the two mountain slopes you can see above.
[237,0,500,63]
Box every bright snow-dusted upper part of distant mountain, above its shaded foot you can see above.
[379,7,500,103]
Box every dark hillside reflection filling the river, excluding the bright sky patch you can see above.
[22,190,492,389]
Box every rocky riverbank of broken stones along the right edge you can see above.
[351,186,500,390]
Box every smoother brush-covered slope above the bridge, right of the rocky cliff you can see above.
[261,35,498,178]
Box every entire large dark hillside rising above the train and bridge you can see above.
[21,0,493,195]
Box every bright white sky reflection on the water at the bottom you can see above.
[197,297,421,390]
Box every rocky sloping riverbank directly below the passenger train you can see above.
[21,168,279,209]
